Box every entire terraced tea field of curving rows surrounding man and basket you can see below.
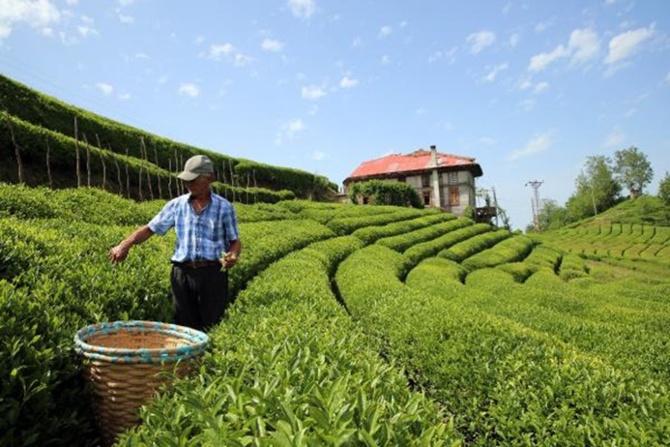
[0,186,670,445]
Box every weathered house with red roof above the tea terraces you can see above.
[344,146,482,215]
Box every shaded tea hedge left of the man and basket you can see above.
[0,218,173,446]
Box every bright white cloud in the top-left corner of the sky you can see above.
[0,0,61,39]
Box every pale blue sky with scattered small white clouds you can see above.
[0,0,670,229]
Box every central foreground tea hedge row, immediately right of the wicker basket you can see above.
[119,236,458,446]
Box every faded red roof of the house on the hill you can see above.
[348,149,481,179]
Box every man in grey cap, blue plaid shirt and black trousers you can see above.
[109,155,242,330]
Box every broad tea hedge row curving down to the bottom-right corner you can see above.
[336,245,670,445]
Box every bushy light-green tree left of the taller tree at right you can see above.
[566,155,621,220]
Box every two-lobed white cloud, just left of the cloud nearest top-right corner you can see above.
[528,28,600,72]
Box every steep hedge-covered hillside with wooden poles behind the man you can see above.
[0,75,337,202]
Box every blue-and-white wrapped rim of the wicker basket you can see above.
[74,320,209,363]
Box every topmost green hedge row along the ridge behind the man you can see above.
[0,75,337,199]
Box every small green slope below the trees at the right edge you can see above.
[567,196,670,228]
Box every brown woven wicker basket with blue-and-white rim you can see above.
[74,321,209,445]
